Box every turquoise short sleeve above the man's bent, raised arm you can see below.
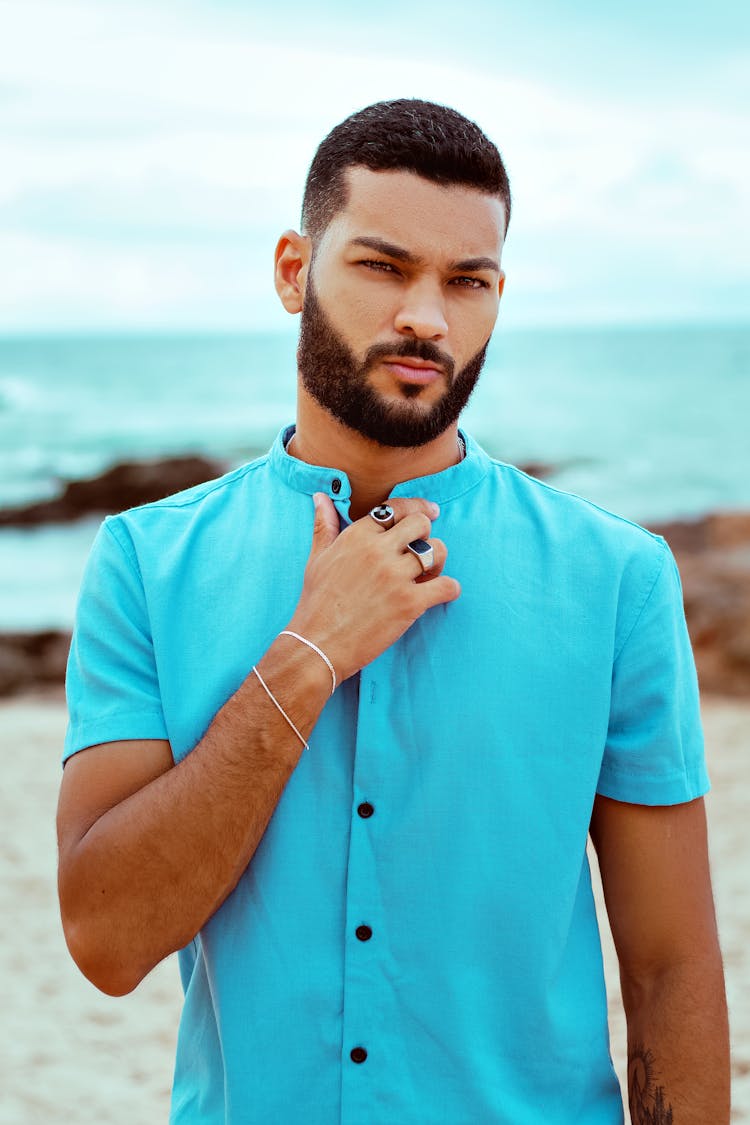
[63,519,168,762]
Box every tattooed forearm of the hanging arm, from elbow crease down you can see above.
[622,953,730,1125]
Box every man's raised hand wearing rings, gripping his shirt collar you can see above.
[289,493,461,683]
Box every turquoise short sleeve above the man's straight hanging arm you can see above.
[597,540,710,804]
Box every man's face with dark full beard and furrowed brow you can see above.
[298,167,505,447]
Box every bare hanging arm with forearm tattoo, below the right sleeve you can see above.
[591,797,730,1125]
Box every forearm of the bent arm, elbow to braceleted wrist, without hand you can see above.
[61,640,331,992]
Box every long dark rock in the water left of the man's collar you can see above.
[0,457,226,528]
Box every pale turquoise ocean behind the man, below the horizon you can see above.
[0,323,750,631]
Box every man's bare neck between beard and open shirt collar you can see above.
[290,394,463,520]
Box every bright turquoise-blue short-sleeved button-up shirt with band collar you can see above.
[65,430,707,1125]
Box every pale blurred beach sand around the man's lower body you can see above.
[0,695,750,1125]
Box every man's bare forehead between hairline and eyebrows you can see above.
[326,165,505,261]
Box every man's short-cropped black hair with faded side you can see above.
[302,98,510,241]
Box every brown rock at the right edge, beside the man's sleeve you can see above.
[651,512,750,698]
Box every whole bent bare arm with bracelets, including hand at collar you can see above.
[57,497,459,995]
